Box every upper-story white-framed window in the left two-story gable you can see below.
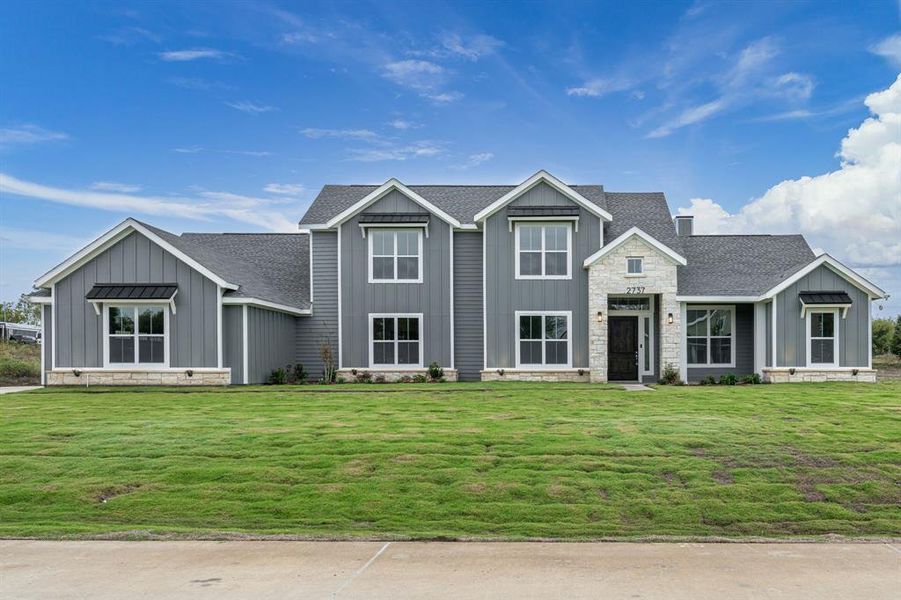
[369,229,422,283]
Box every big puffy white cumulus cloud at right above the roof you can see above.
[678,75,901,272]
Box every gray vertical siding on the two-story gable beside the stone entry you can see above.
[485,183,601,369]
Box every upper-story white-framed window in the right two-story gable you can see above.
[515,223,572,279]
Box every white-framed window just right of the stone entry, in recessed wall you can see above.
[685,306,735,367]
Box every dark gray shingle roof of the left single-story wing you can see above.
[142,223,310,309]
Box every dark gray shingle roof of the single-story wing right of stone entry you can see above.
[678,235,815,296]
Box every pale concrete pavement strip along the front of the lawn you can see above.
[0,541,901,600]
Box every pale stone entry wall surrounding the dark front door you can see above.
[588,236,682,382]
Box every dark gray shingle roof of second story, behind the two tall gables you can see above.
[300,185,606,225]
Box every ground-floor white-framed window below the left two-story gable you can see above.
[369,314,422,367]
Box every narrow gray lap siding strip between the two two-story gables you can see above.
[454,232,484,381]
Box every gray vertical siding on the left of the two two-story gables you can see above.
[338,191,451,368]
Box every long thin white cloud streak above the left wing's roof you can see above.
[0,173,296,231]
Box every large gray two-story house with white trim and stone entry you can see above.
[32,171,885,384]
